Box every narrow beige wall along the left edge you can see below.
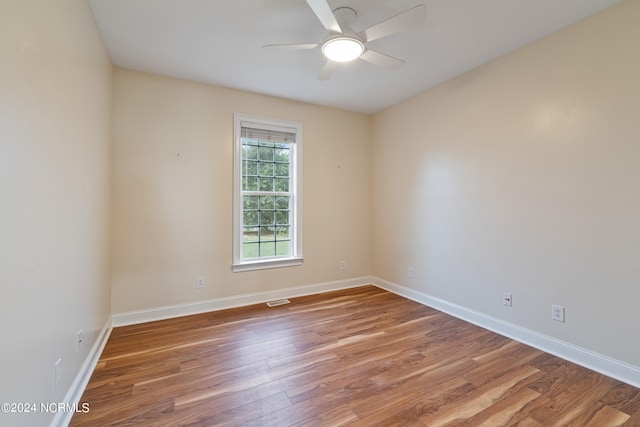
[0,0,111,426]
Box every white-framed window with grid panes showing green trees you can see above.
[233,113,302,271]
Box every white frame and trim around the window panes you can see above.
[232,113,304,272]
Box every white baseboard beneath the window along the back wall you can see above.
[112,277,371,327]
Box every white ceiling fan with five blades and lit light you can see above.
[262,0,427,80]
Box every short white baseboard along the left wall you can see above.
[51,318,113,427]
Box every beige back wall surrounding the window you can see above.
[112,69,371,313]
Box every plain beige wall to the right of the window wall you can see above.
[372,1,640,366]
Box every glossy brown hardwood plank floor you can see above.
[71,286,640,427]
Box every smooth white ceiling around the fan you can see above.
[89,0,620,113]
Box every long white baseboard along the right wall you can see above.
[371,277,640,387]
